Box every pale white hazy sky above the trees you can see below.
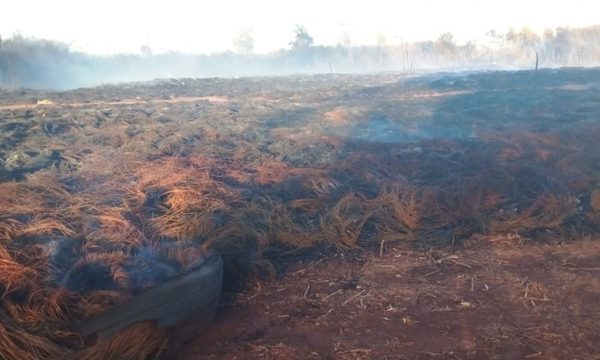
[0,0,600,54]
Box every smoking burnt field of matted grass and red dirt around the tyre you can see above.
[0,69,600,359]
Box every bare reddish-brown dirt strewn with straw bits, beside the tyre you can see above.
[173,238,600,359]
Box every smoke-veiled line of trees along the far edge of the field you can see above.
[0,25,600,89]
